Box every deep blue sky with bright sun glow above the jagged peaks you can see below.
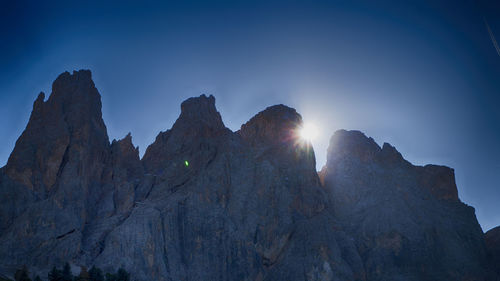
[0,0,500,231]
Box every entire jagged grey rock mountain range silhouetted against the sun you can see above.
[0,70,500,281]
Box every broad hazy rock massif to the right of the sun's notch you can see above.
[321,130,493,280]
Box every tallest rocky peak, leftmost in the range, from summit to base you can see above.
[0,70,142,270]
